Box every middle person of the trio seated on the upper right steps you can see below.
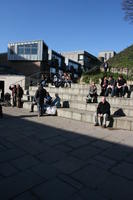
[105,76,116,97]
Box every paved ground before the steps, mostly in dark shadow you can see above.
[0,108,133,200]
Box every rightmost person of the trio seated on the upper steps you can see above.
[116,75,130,97]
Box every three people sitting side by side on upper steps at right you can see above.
[100,75,131,98]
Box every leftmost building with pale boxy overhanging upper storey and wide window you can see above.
[7,40,48,76]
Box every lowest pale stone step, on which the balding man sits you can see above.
[58,108,133,131]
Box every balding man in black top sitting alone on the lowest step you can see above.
[94,97,110,128]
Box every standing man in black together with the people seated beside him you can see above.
[30,84,61,117]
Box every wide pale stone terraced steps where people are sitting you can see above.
[23,84,133,131]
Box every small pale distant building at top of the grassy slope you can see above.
[98,51,116,62]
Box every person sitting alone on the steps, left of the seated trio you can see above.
[86,82,98,103]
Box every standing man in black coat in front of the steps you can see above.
[35,85,46,117]
